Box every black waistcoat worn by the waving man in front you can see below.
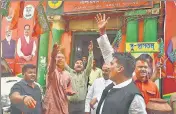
[96,82,142,114]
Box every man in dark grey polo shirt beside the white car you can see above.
[9,64,42,114]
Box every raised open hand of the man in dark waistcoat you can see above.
[95,13,110,35]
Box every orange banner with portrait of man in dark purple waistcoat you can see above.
[1,2,18,72]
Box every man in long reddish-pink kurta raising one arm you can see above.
[43,44,75,114]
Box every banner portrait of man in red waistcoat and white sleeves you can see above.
[17,24,36,61]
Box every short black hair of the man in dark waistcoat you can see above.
[113,52,136,77]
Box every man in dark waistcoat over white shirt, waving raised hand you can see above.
[96,14,147,114]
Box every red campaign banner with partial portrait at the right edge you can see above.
[163,1,176,95]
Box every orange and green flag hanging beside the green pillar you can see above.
[32,3,50,37]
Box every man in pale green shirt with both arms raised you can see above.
[65,41,93,114]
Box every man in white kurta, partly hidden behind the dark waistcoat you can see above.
[85,64,112,114]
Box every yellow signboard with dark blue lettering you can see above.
[126,42,159,53]
